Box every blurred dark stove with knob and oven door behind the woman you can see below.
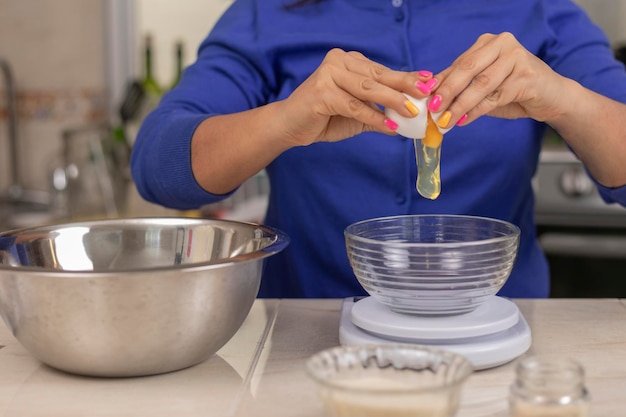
[533,142,626,298]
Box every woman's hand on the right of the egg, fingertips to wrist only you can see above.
[428,33,565,124]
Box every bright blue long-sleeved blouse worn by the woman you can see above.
[132,0,626,297]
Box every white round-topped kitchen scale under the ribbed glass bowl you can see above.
[339,296,531,370]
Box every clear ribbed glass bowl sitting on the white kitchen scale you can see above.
[344,215,520,315]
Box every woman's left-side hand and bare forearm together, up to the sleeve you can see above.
[191,49,436,194]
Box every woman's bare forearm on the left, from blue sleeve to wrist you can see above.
[191,102,292,194]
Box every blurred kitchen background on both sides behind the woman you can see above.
[0,0,626,297]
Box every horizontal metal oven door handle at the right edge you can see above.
[539,233,626,258]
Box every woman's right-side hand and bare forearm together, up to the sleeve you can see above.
[431,33,626,187]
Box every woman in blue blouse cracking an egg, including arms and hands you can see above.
[132,0,626,297]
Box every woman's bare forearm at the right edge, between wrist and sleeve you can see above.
[547,80,626,187]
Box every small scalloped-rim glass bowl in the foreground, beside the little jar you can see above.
[306,344,473,417]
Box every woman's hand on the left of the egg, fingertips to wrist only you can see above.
[279,49,432,146]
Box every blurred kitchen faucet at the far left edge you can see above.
[0,57,49,205]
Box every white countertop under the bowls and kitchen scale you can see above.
[0,299,626,417]
